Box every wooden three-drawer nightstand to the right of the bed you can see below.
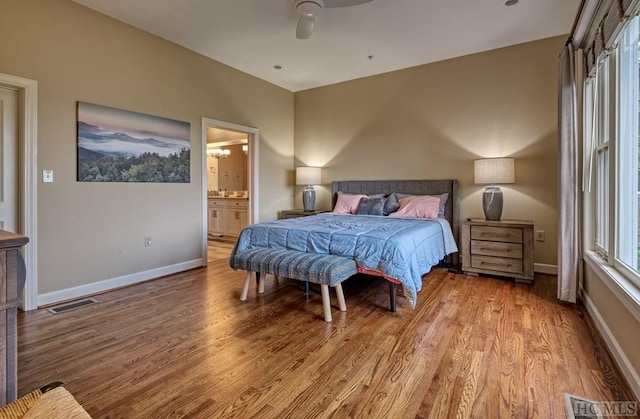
[462,219,533,284]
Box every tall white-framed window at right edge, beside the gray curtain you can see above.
[584,15,640,287]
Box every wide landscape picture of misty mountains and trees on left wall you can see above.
[78,102,191,183]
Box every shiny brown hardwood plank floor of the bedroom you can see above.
[18,244,634,418]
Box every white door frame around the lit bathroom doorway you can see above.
[201,117,260,266]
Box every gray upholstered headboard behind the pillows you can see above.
[331,179,460,265]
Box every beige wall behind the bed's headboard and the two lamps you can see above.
[295,36,566,265]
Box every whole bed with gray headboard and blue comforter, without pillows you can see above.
[230,179,460,311]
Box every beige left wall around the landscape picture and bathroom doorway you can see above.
[0,0,293,294]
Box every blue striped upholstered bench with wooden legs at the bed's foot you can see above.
[229,248,358,322]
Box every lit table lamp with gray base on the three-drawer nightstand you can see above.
[473,157,515,221]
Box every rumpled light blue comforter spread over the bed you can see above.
[232,213,458,307]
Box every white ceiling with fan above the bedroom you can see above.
[74,0,580,92]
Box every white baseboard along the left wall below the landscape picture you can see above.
[38,259,205,307]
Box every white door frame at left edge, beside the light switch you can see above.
[0,73,38,310]
